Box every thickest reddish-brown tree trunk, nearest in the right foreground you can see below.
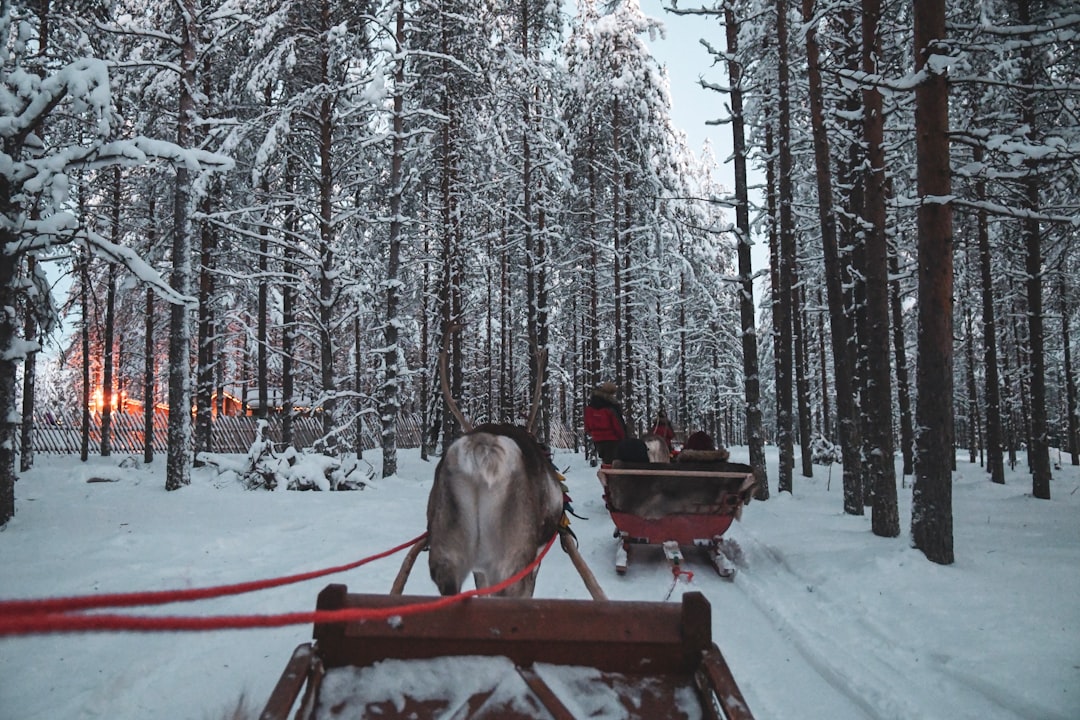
[912,0,954,565]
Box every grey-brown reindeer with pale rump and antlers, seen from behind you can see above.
[428,328,563,598]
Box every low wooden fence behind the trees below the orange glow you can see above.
[21,410,575,454]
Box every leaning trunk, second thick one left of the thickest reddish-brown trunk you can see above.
[802,0,864,515]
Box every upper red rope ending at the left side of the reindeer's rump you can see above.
[0,532,428,616]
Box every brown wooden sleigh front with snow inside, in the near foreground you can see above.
[260,585,753,720]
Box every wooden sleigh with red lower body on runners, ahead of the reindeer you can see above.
[597,460,756,579]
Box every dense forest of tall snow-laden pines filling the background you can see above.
[0,0,1080,562]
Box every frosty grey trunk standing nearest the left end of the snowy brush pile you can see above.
[165,0,199,490]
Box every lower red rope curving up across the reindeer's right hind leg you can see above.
[0,533,558,637]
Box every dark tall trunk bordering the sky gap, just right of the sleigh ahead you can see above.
[721,8,769,492]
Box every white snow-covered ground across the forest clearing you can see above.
[0,448,1080,720]
